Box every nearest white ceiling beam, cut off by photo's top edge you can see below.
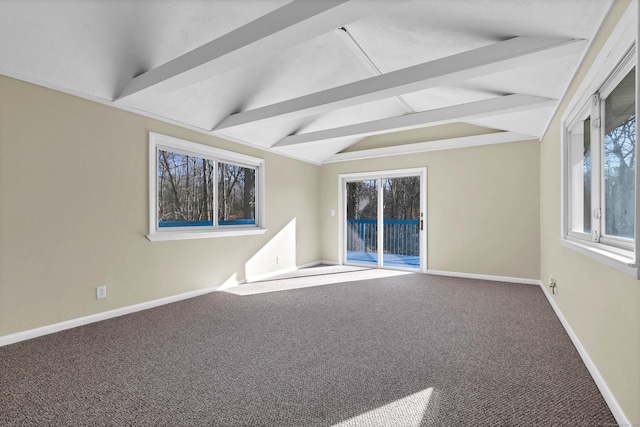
[115,0,392,106]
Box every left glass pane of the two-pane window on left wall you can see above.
[158,150,213,227]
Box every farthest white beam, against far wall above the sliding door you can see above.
[322,132,538,164]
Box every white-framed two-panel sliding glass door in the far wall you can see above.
[341,170,426,270]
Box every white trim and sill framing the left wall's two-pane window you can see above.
[147,132,267,242]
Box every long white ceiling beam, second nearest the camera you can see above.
[215,37,586,130]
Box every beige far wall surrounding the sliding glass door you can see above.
[321,141,540,279]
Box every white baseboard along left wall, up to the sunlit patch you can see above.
[0,281,242,347]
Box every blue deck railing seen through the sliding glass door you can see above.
[347,219,420,256]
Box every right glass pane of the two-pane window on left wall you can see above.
[218,163,256,226]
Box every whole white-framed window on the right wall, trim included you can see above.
[562,3,640,278]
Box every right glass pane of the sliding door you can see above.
[382,176,420,269]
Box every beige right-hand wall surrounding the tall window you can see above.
[540,1,640,425]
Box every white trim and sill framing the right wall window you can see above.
[560,2,640,279]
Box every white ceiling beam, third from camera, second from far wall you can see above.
[272,94,558,148]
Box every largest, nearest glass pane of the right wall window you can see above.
[604,68,636,239]
